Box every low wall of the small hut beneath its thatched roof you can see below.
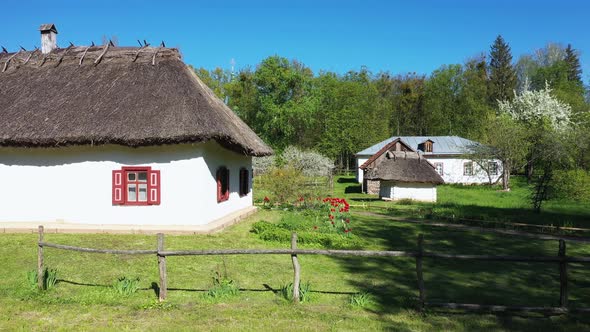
[379,181,436,202]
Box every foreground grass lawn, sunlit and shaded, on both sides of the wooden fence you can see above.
[0,178,590,331]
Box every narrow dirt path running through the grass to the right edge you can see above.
[353,211,590,243]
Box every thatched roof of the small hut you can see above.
[365,151,444,184]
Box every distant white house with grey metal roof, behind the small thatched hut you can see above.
[356,136,502,194]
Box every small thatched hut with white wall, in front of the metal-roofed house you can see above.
[365,151,444,202]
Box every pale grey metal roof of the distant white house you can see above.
[357,136,479,156]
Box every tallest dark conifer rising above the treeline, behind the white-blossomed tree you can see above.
[489,35,516,106]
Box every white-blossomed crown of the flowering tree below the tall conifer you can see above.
[498,83,572,130]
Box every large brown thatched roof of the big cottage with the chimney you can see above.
[0,45,272,156]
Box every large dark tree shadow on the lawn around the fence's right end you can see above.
[334,211,590,330]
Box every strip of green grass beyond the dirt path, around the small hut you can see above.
[334,176,590,228]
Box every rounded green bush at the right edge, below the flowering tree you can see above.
[551,169,590,202]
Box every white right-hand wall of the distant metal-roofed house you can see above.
[426,156,502,184]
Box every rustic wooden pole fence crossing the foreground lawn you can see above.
[37,226,590,314]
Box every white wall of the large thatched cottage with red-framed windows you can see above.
[0,142,252,225]
